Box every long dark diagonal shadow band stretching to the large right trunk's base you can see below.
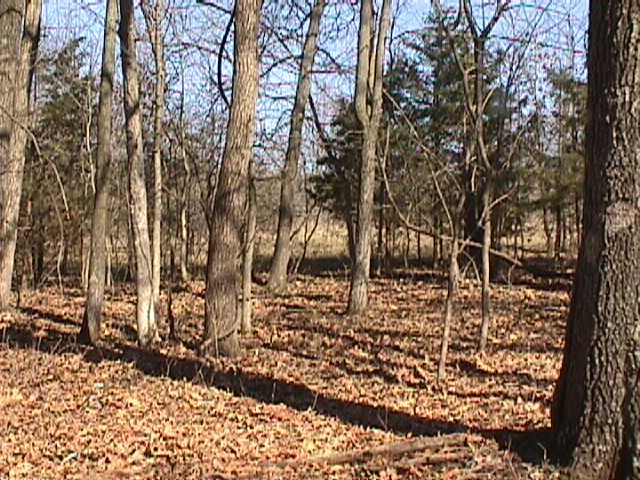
[0,313,551,464]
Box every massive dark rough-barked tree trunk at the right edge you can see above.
[552,0,640,480]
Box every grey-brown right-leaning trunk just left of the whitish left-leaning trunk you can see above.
[80,0,118,344]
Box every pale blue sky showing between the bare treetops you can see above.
[43,0,588,168]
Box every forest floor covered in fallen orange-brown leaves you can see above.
[0,271,569,480]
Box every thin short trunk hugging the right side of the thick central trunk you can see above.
[240,169,257,334]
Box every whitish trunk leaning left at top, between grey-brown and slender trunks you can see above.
[118,0,157,346]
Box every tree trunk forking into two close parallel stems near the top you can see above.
[347,0,392,315]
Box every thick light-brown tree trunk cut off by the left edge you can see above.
[0,0,42,311]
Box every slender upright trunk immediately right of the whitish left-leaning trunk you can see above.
[141,0,166,315]
